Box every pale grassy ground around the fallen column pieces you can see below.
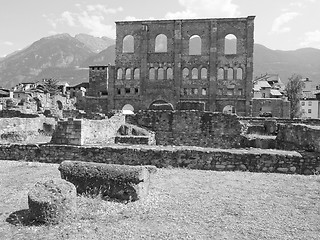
[0,161,320,240]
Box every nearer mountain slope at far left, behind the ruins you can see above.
[0,34,94,87]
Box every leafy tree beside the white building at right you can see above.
[285,74,304,118]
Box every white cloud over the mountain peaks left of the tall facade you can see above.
[43,4,123,38]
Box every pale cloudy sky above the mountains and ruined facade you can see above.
[0,0,320,57]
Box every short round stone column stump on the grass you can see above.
[28,179,76,224]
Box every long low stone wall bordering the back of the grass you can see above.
[0,144,320,174]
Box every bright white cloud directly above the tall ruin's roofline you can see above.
[165,0,240,19]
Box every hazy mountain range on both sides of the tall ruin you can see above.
[0,33,320,88]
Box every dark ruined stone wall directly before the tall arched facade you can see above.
[127,111,244,148]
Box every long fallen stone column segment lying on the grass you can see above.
[59,161,150,201]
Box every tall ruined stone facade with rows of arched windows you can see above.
[108,16,254,115]
